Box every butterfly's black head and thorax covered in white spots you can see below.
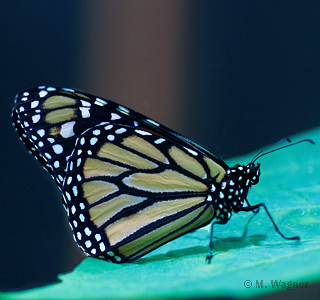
[212,163,260,221]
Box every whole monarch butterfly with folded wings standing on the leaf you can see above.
[12,86,313,263]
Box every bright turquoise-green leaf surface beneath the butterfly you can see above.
[1,129,320,299]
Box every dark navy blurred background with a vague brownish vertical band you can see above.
[0,0,320,290]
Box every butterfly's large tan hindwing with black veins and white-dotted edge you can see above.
[62,122,225,262]
